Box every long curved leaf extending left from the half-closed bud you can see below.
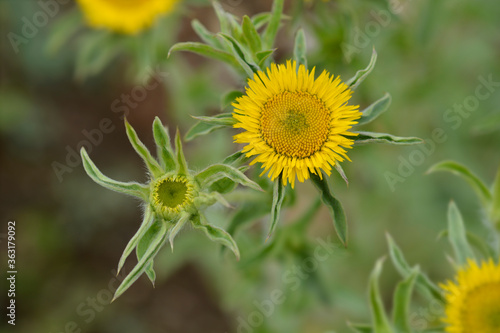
[80,147,149,200]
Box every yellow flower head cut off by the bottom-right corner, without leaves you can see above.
[441,259,500,333]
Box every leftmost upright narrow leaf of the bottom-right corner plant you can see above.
[369,258,393,333]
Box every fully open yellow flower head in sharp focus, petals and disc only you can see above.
[233,61,361,188]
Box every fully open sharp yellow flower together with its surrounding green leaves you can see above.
[170,0,422,245]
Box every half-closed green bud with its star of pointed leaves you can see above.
[81,118,261,299]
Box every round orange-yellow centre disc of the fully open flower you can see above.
[261,91,330,158]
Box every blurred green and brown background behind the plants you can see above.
[0,0,500,333]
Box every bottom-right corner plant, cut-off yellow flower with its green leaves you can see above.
[351,161,500,333]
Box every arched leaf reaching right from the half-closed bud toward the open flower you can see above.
[195,164,263,191]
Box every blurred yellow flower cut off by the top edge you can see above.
[77,0,177,34]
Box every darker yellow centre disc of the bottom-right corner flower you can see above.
[463,283,500,333]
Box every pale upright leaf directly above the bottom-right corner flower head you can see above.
[448,201,475,266]
